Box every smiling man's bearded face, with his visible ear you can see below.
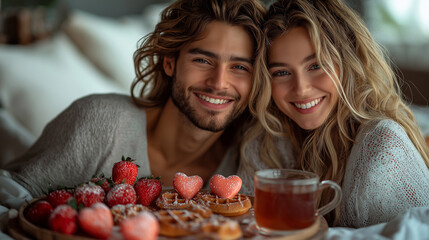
[164,21,253,132]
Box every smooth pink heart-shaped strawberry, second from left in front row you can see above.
[78,203,113,239]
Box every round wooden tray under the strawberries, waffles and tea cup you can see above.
[7,197,328,240]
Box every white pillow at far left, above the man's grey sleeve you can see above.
[0,33,129,137]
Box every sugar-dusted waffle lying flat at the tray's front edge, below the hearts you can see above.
[155,209,242,240]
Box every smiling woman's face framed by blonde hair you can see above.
[268,27,338,130]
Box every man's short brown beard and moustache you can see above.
[171,76,243,132]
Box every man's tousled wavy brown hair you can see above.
[131,0,269,139]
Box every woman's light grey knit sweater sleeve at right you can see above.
[338,120,429,227]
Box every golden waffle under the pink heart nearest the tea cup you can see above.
[194,192,252,217]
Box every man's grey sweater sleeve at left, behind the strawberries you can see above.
[6,96,126,197]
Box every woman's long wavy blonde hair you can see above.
[241,0,429,225]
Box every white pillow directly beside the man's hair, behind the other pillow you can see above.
[64,10,148,89]
